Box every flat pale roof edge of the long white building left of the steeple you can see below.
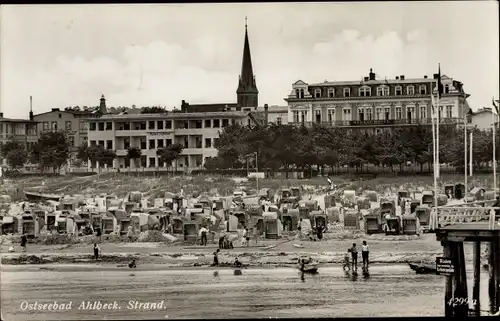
[84,111,254,120]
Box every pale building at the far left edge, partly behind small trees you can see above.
[0,113,38,166]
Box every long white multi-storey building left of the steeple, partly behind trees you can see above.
[88,111,253,170]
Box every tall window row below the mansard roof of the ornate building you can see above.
[293,106,453,123]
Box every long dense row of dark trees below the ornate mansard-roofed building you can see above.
[205,124,500,172]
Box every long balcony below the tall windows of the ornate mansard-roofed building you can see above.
[289,118,464,127]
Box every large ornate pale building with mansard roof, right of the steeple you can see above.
[285,69,469,131]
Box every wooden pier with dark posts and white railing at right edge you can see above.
[430,201,500,317]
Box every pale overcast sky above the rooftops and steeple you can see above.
[0,1,499,118]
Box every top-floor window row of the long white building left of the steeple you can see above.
[89,119,236,131]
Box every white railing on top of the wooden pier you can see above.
[429,200,500,230]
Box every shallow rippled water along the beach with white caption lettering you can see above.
[1,265,487,320]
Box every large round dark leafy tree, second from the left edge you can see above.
[31,132,70,171]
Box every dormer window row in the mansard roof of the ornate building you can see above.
[295,85,450,99]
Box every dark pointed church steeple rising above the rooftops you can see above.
[236,17,259,108]
